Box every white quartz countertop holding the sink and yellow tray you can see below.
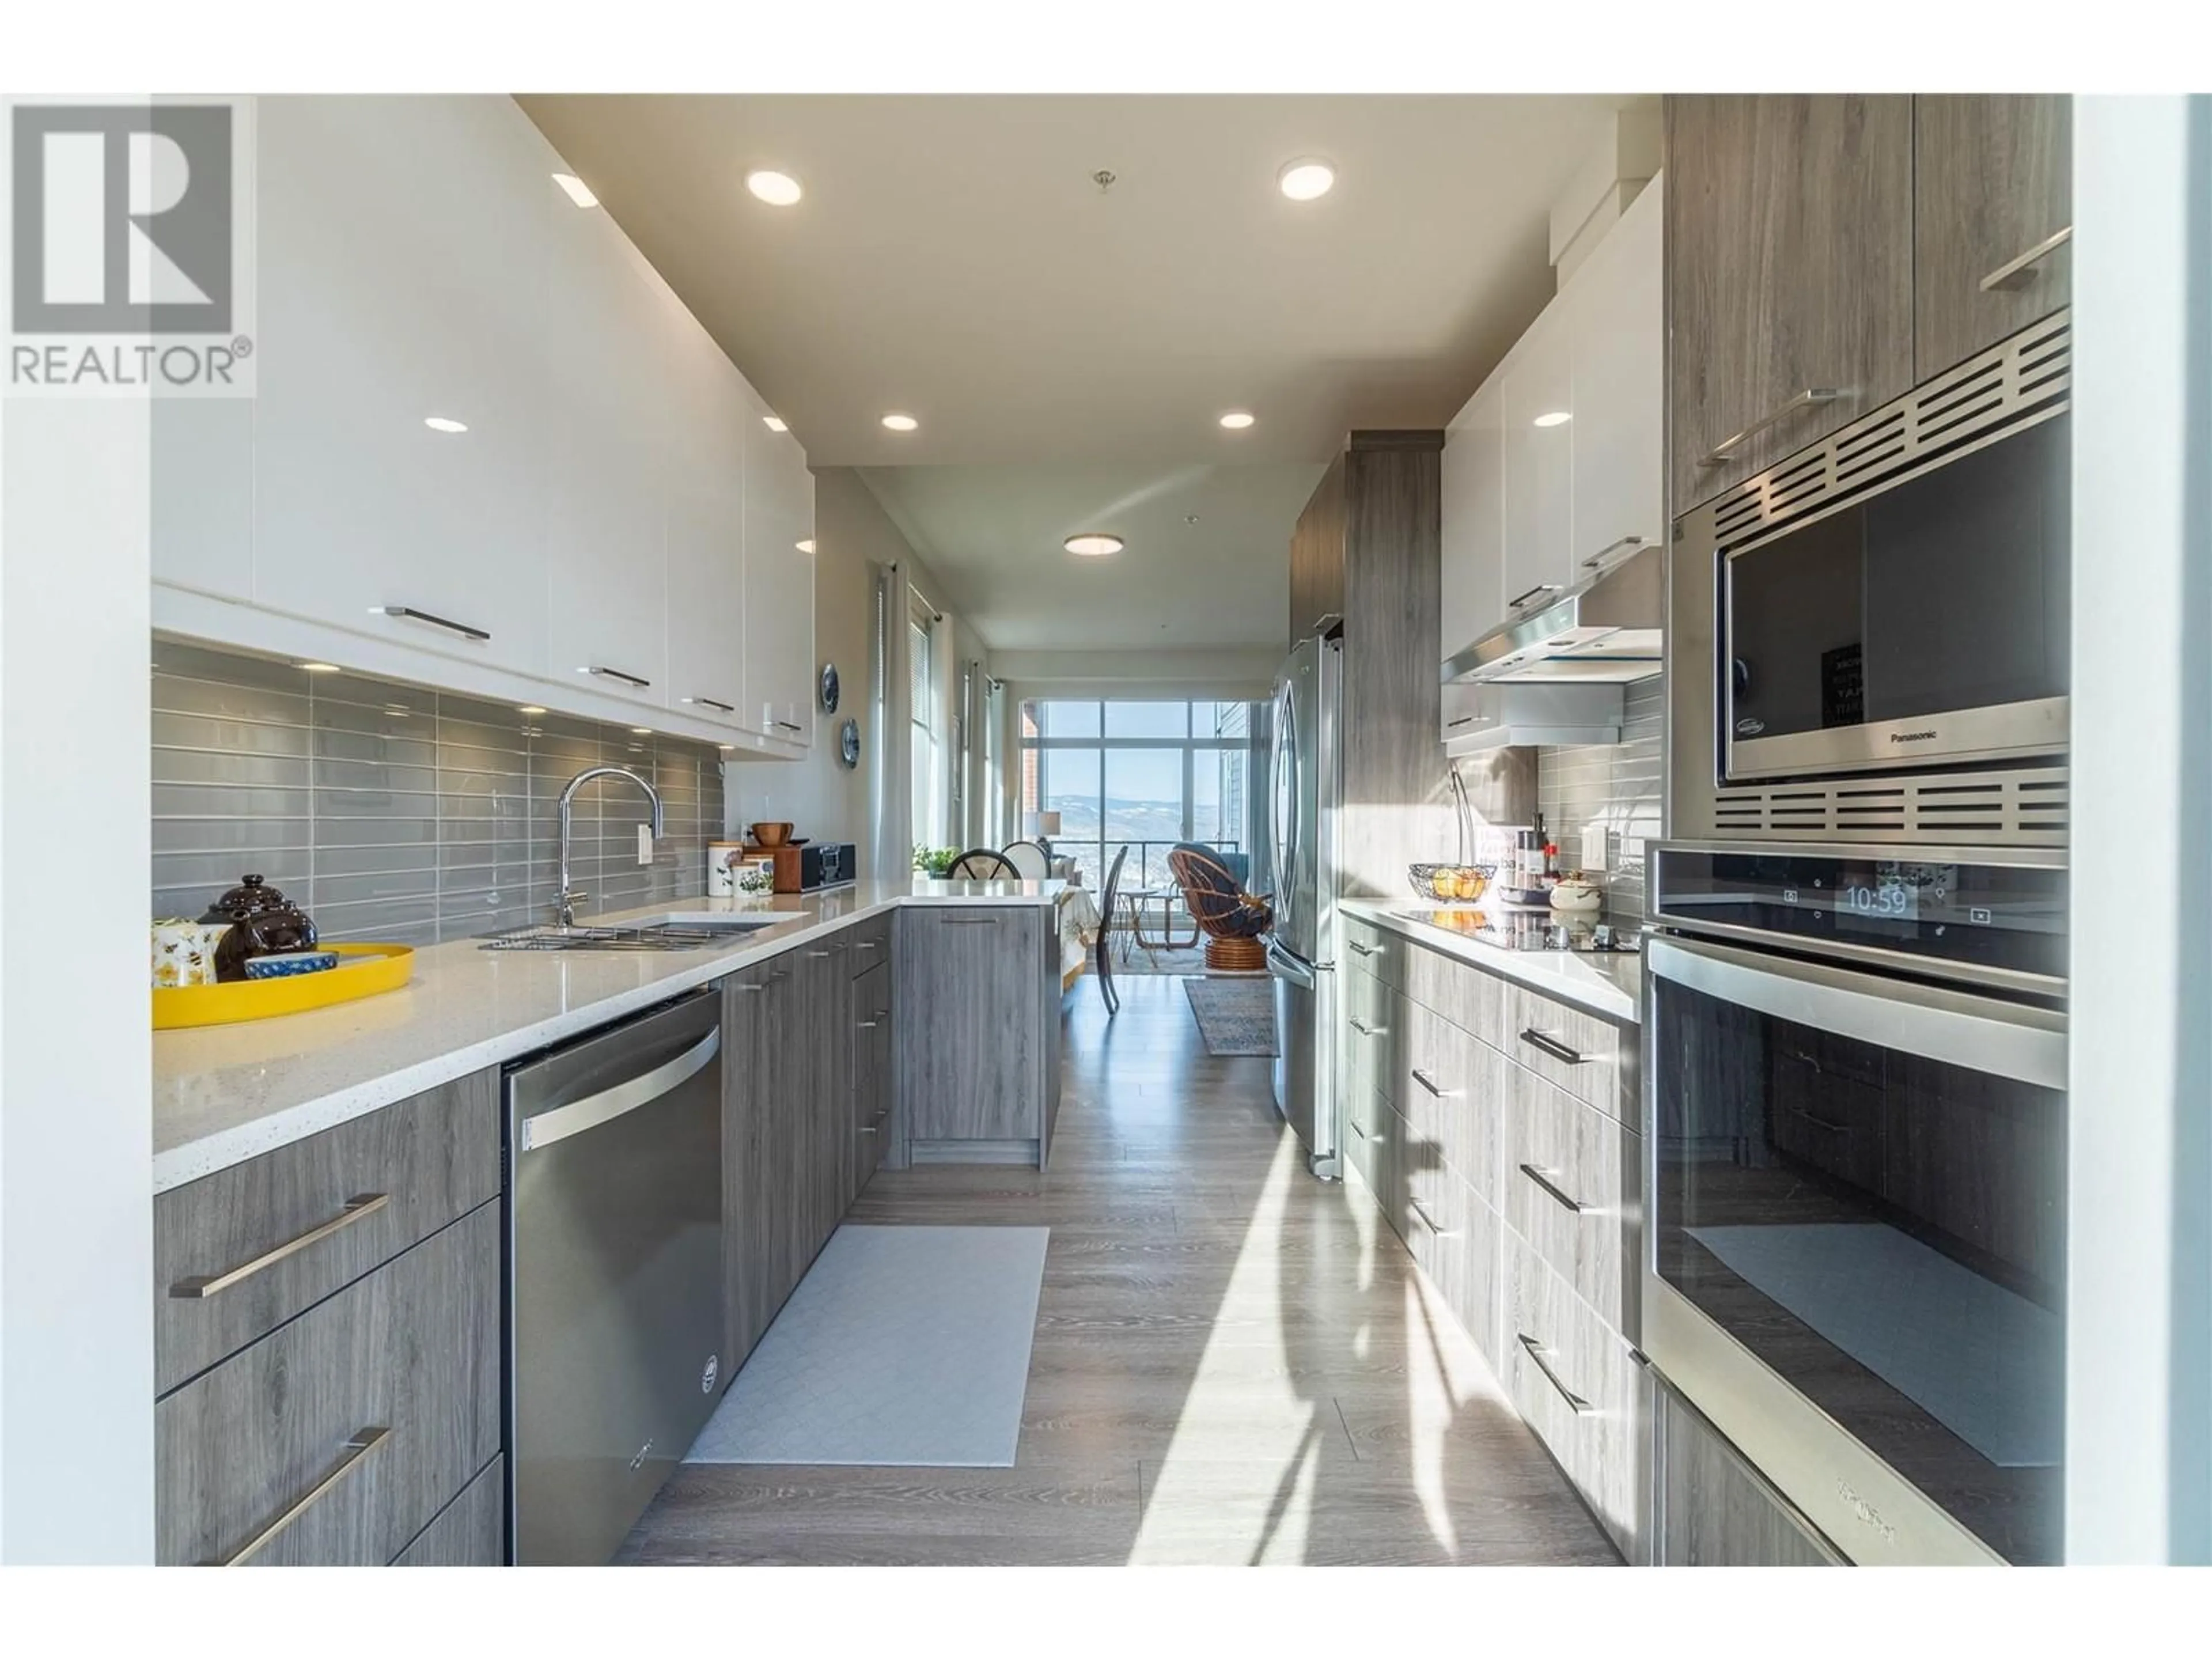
[153,878,1066,1192]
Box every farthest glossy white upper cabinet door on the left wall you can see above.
[745,400,814,743]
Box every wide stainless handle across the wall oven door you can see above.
[1643,938,2066,1088]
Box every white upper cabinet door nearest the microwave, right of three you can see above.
[1566,179,1666,582]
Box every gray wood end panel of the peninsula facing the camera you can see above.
[893,905,1059,1166]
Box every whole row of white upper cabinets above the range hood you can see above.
[1442,179,1666,677]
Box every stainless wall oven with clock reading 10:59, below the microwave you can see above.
[1643,843,2066,1564]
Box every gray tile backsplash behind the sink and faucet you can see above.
[153,639,724,945]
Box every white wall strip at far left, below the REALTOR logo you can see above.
[0,393,153,1562]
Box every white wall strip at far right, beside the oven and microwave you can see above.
[2066,97,2212,1562]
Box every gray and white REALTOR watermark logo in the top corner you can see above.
[5,100,255,396]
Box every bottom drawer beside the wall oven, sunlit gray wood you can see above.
[1498,1228,1650,1562]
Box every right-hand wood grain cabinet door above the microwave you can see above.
[1914,93,2073,380]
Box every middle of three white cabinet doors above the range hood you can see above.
[1504,297,1575,613]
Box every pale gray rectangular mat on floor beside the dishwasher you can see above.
[684,1225,1051,1469]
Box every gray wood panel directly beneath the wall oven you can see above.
[1652,1382,1843,1566]
